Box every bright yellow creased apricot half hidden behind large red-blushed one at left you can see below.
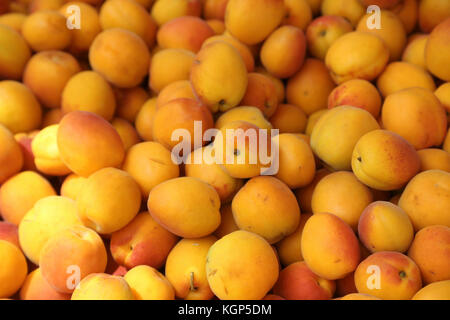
[31,124,71,176]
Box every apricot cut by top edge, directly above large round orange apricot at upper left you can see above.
[99,0,158,47]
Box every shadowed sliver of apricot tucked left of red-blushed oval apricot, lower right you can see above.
[276,213,312,266]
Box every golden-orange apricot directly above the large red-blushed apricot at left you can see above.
[61,71,116,121]
